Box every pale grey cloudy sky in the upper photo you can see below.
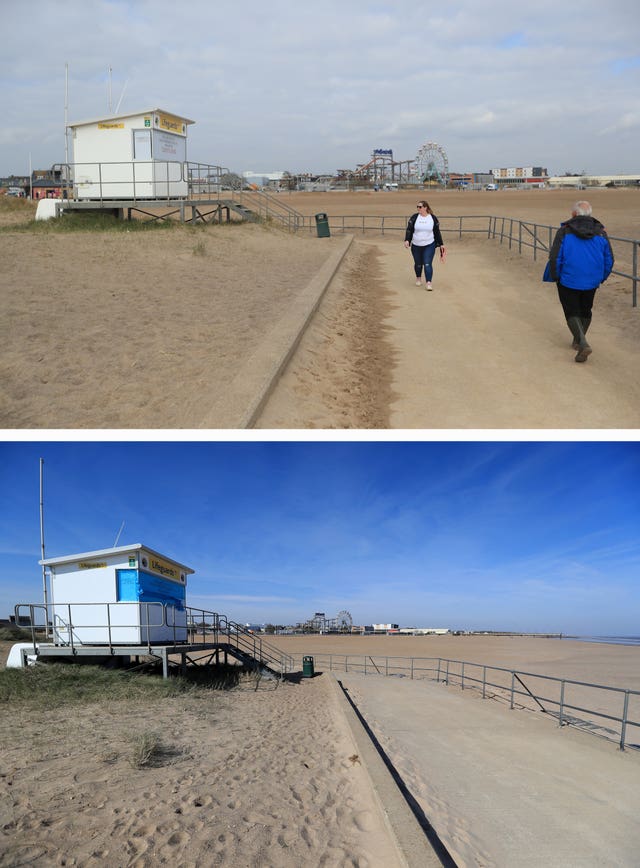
[0,0,640,175]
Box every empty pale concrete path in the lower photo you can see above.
[336,673,640,868]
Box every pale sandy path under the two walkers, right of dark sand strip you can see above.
[372,239,640,429]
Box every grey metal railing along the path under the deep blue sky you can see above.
[296,654,640,750]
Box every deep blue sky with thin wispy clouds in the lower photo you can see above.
[0,442,640,635]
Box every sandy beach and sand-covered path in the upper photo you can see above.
[0,190,640,429]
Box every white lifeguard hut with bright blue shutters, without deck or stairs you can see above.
[39,543,194,646]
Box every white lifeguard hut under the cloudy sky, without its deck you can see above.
[68,108,195,200]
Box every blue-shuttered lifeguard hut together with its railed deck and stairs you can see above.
[7,543,295,678]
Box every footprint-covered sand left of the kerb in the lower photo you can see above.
[0,640,402,868]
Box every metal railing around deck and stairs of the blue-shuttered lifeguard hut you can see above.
[15,602,295,674]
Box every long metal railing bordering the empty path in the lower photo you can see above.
[298,654,640,750]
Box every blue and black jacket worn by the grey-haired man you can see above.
[549,216,613,289]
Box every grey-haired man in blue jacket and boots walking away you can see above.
[548,202,613,362]
